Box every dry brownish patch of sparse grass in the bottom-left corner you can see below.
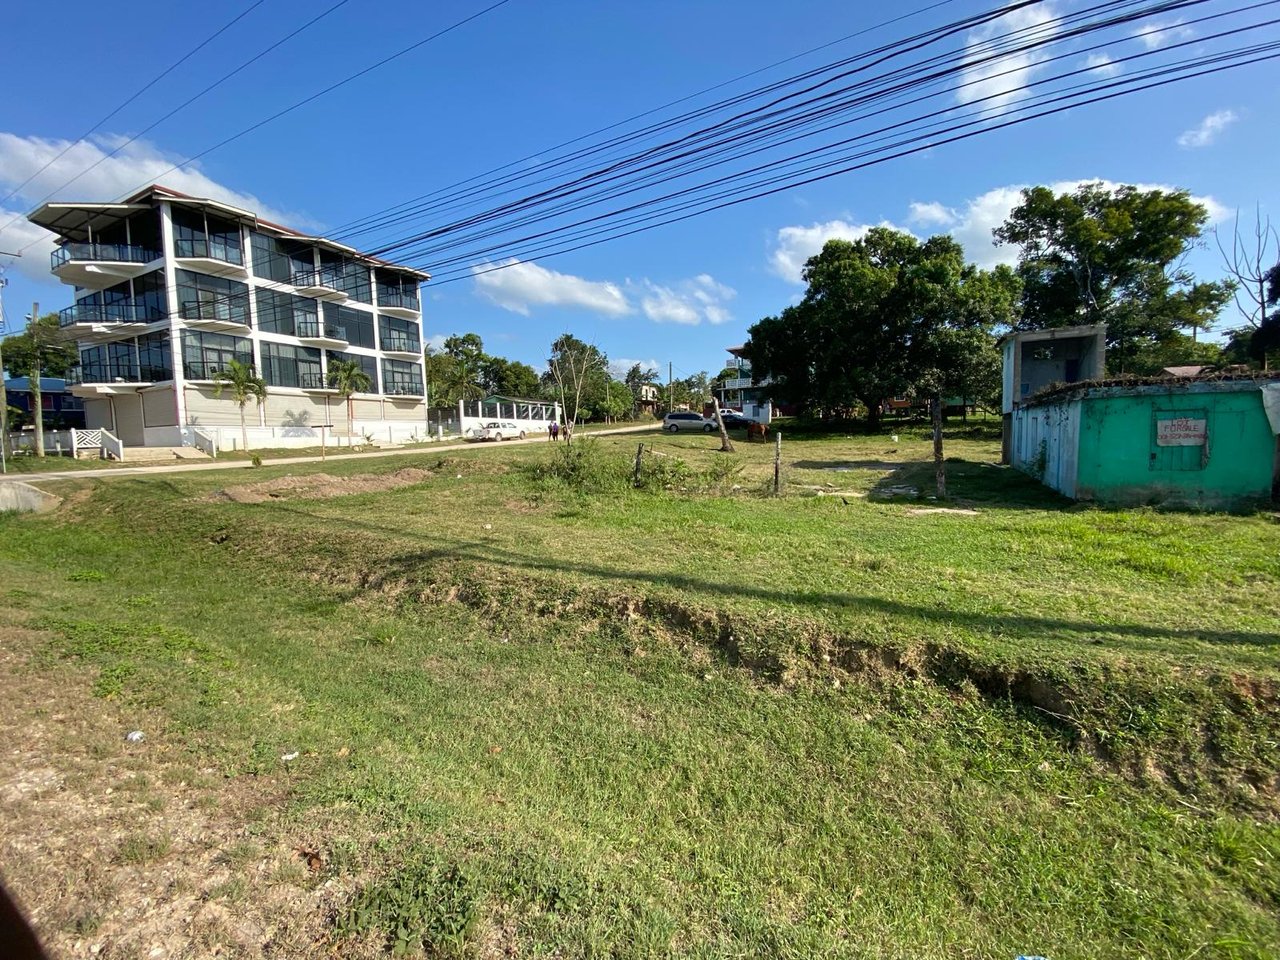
[0,609,360,959]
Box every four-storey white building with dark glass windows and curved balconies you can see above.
[28,186,430,447]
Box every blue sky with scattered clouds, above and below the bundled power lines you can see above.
[0,0,1280,376]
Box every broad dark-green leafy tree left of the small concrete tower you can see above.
[744,228,1019,429]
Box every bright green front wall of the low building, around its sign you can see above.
[1076,383,1276,508]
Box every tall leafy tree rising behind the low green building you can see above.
[995,183,1234,372]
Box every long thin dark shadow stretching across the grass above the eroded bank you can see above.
[253,503,1280,648]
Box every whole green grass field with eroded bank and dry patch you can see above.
[0,426,1280,960]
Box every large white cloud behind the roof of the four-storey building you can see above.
[0,132,317,280]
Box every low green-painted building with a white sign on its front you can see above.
[1011,374,1280,508]
